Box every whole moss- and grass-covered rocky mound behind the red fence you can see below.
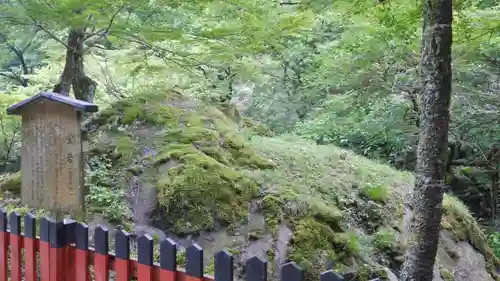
[0,91,500,281]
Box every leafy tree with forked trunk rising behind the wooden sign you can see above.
[0,0,308,103]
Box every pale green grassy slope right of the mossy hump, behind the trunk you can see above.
[245,137,498,277]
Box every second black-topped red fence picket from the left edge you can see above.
[9,212,23,281]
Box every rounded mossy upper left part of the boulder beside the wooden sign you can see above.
[89,91,274,234]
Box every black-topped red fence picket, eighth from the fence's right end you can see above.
[115,230,130,281]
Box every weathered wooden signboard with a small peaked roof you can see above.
[7,93,98,212]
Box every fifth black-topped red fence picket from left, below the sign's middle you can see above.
[49,220,69,281]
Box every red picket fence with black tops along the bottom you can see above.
[0,210,366,281]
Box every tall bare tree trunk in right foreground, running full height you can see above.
[401,0,452,281]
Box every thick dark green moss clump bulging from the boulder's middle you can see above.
[157,158,257,234]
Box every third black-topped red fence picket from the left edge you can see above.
[24,214,37,281]
